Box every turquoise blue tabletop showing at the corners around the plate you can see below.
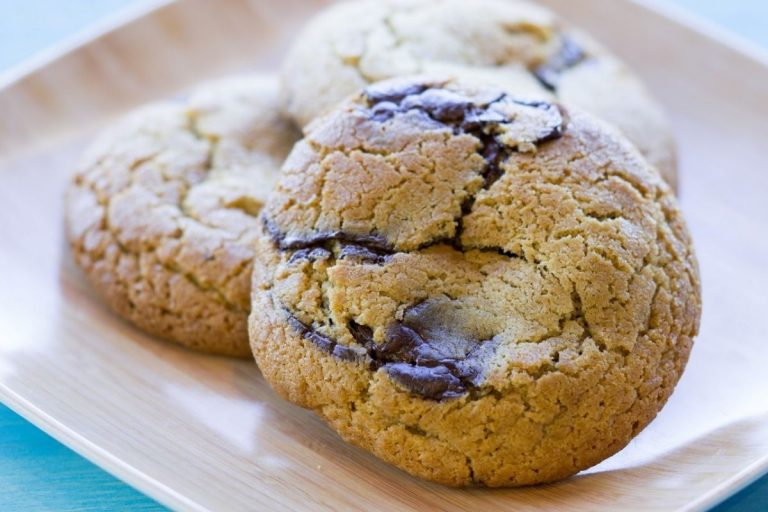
[0,0,768,512]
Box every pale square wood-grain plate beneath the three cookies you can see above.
[0,0,768,511]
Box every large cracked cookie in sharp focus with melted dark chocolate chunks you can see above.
[249,78,700,486]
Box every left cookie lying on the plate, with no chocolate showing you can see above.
[65,76,299,357]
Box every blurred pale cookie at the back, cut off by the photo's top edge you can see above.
[282,0,677,187]
